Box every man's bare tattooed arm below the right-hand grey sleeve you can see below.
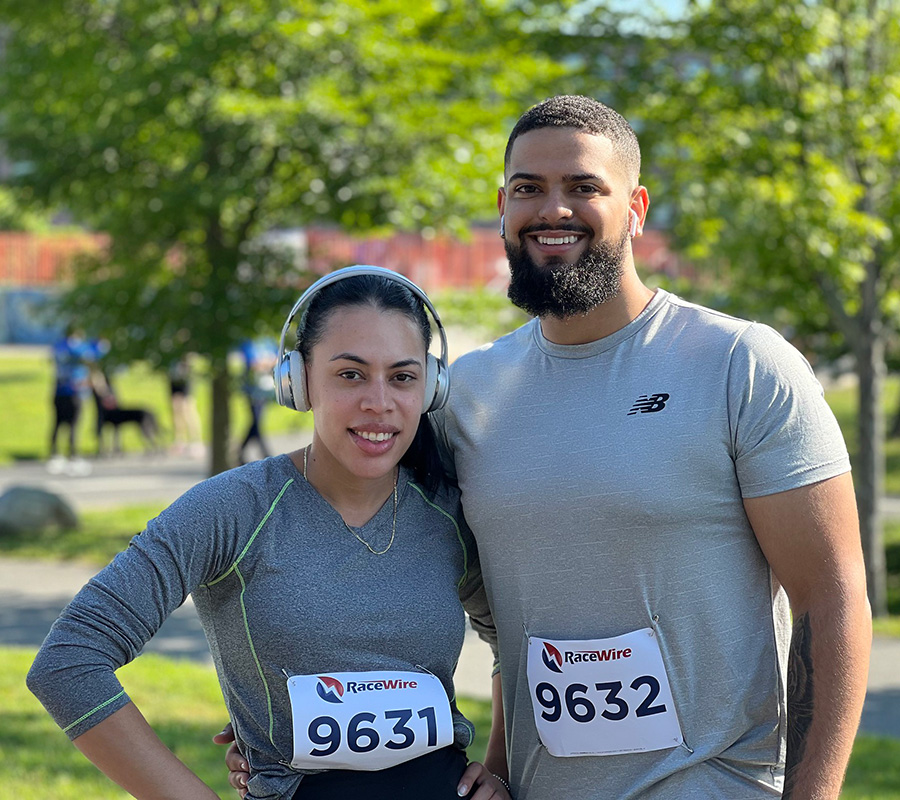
[744,473,872,800]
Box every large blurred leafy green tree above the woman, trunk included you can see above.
[0,0,559,472]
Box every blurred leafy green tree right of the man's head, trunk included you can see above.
[600,0,900,615]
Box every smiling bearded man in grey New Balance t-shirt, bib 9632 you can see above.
[223,97,871,800]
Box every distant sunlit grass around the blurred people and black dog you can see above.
[0,348,312,465]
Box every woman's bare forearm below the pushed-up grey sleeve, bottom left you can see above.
[73,703,218,800]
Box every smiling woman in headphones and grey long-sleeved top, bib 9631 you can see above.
[28,268,508,800]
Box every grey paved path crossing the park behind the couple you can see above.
[0,444,900,738]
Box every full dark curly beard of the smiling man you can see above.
[505,223,628,318]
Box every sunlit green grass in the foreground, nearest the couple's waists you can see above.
[0,648,900,800]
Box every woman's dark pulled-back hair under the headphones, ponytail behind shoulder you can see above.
[297,275,447,497]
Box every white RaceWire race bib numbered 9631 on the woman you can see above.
[287,672,453,770]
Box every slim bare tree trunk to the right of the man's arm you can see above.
[856,336,887,617]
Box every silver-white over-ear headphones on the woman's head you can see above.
[274,264,450,414]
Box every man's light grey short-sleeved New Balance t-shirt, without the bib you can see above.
[439,291,850,800]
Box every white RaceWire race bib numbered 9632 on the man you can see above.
[528,628,683,757]
